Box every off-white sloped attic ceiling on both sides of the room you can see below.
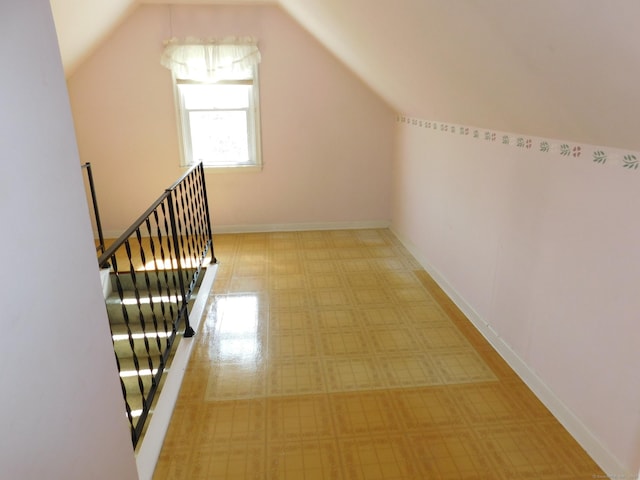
[51,0,640,150]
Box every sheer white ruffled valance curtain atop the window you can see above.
[160,37,260,82]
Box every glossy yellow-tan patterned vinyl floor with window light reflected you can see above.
[154,230,603,480]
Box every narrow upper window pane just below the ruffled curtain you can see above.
[180,85,251,110]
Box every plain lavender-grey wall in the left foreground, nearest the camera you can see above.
[0,0,138,480]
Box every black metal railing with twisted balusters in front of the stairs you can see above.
[98,164,216,447]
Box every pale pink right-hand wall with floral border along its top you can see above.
[392,117,640,478]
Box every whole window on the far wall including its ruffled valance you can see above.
[162,38,262,168]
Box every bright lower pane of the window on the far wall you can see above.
[189,111,250,165]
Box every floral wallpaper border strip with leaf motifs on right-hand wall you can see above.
[397,115,640,170]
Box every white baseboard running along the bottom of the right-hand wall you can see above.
[391,227,640,480]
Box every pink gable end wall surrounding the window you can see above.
[68,5,395,233]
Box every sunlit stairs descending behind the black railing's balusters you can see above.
[102,269,204,444]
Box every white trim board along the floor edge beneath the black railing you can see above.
[136,264,218,480]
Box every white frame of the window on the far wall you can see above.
[172,65,263,173]
